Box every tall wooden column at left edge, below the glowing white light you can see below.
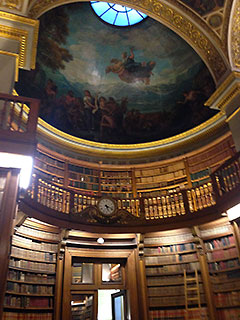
[0,168,20,319]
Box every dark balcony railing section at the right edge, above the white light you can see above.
[211,152,240,197]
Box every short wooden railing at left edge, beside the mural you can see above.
[0,93,39,135]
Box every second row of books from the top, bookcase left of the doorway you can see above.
[12,235,58,252]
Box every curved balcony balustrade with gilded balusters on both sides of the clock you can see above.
[28,174,216,220]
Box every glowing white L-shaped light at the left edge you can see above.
[0,152,33,189]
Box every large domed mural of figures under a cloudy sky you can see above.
[16,3,216,144]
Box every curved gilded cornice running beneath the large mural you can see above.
[35,112,225,158]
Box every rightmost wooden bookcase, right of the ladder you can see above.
[200,219,240,320]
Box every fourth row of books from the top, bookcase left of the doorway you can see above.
[9,258,55,272]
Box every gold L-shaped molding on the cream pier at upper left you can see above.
[0,11,39,69]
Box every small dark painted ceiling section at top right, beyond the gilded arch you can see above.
[181,0,225,16]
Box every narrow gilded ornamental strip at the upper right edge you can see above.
[231,0,240,68]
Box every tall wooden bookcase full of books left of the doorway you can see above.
[3,219,59,320]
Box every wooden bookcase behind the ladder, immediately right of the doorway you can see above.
[144,229,207,319]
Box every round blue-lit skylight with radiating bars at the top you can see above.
[91,1,147,27]
